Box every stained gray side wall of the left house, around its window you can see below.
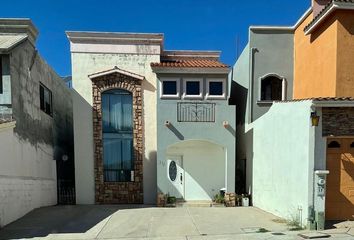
[0,41,73,225]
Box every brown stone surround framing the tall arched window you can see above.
[92,72,144,204]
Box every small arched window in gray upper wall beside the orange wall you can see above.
[261,75,284,101]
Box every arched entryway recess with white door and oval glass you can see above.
[165,140,226,201]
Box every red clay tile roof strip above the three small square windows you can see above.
[150,59,229,68]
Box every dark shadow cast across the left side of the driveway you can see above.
[0,205,155,239]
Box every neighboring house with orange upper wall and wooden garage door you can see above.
[232,0,354,228]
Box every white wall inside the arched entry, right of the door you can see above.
[166,140,227,201]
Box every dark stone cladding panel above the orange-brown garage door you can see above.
[322,107,354,136]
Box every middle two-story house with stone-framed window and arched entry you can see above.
[67,32,235,204]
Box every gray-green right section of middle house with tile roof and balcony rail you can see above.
[151,51,235,201]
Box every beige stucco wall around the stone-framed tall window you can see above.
[71,49,160,204]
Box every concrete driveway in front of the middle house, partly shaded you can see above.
[0,205,354,240]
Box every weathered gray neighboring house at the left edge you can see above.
[0,19,73,227]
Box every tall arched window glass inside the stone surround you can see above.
[102,89,134,182]
